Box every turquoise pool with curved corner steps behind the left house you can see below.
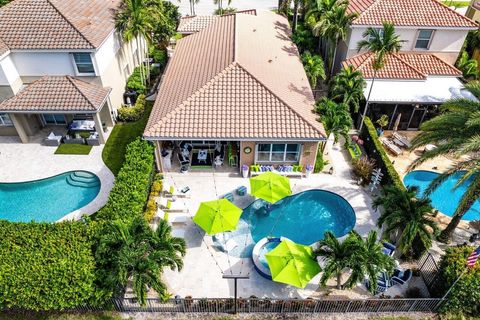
[0,171,100,222]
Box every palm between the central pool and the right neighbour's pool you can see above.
[373,186,438,256]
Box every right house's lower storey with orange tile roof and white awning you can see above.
[343,52,475,130]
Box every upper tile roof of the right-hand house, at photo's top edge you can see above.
[348,0,478,28]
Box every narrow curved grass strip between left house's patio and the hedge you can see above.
[102,101,153,176]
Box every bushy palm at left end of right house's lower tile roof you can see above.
[330,66,366,112]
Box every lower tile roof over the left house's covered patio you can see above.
[0,76,110,112]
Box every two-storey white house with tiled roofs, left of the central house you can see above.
[0,0,144,142]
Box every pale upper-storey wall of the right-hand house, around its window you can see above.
[346,27,468,64]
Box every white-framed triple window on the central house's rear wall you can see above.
[256,143,300,162]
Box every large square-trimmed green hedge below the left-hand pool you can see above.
[0,221,96,311]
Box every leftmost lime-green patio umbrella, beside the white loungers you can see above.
[193,199,242,235]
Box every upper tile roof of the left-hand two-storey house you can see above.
[0,0,120,50]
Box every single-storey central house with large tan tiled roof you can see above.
[144,12,326,171]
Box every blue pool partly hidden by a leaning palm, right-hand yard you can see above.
[403,170,480,221]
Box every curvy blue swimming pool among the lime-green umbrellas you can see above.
[214,189,356,257]
